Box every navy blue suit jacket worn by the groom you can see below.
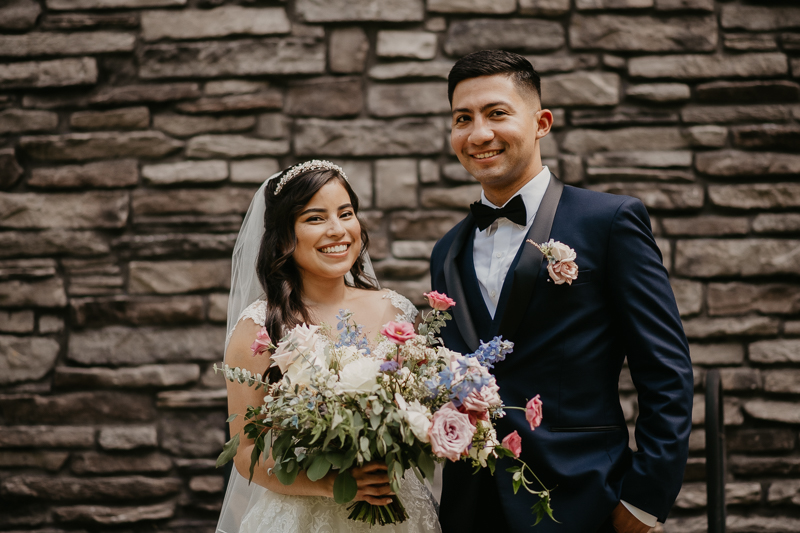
[431,178,693,533]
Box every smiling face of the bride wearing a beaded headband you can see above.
[293,179,361,278]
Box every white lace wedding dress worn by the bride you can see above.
[218,291,441,533]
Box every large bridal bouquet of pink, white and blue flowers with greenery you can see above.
[214,292,552,525]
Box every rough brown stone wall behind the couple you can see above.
[0,0,800,533]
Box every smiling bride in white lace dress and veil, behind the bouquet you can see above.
[217,160,440,533]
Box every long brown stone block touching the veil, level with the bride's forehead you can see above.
[132,187,256,215]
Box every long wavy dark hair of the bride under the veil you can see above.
[256,167,377,379]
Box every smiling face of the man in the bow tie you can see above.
[450,74,541,192]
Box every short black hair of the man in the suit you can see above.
[447,50,542,104]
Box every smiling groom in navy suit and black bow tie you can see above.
[431,50,693,533]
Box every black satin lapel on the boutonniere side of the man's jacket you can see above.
[496,175,564,339]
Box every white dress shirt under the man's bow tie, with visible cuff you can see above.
[472,167,657,527]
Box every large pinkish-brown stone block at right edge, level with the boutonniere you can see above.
[675,239,800,277]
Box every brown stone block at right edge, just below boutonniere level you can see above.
[708,282,800,315]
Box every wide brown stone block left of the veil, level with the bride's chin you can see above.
[129,259,231,294]
